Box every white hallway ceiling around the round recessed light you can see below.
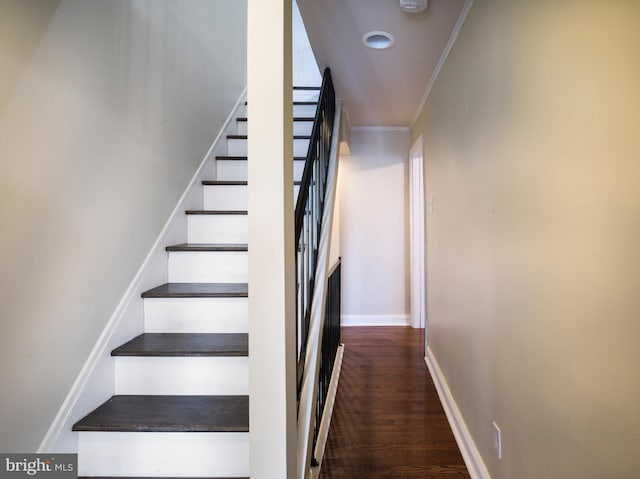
[297,0,464,126]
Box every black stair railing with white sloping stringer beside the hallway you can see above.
[295,68,340,478]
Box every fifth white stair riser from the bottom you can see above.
[187,215,249,243]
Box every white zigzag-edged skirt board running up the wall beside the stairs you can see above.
[38,88,246,453]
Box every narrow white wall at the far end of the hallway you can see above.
[338,127,411,324]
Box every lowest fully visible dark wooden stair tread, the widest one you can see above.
[73,395,249,432]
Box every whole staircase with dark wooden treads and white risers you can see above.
[73,87,319,478]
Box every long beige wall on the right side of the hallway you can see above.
[411,0,640,479]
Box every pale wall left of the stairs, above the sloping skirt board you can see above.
[0,0,246,452]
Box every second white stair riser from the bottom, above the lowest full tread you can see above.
[115,356,249,396]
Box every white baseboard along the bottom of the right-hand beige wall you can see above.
[424,347,491,479]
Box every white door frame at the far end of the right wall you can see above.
[409,135,427,334]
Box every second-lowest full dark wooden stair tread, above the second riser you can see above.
[111,333,249,357]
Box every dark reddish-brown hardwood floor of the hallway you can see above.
[320,327,469,479]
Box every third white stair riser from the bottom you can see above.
[144,298,249,333]
